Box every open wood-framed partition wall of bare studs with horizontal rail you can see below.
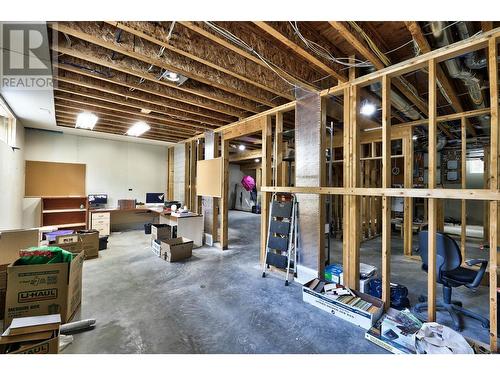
[178,29,500,352]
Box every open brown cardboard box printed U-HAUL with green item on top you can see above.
[4,252,85,327]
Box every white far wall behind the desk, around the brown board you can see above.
[25,129,167,212]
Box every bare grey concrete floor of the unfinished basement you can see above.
[64,211,487,353]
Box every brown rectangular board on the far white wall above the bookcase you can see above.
[25,160,86,197]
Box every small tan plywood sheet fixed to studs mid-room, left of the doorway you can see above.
[196,158,222,198]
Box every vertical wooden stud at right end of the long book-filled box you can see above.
[382,76,392,309]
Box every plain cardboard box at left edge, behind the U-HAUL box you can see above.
[0,229,39,320]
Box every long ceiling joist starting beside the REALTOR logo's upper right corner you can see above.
[49,22,277,107]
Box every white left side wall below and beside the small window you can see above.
[0,121,25,230]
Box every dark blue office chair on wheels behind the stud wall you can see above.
[413,230,490,331]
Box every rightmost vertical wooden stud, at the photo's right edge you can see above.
[488,39,500,353]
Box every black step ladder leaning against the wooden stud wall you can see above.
[262,193,297,285]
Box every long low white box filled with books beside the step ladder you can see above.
[302,280,384,329]
